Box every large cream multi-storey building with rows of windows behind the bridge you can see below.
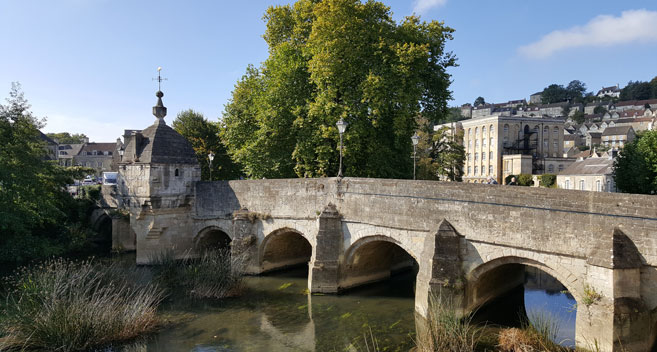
[460,116,571,183]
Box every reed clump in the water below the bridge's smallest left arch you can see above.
[151,249,244,298]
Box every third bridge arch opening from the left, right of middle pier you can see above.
[339,235,419,289]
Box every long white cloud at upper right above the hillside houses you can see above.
[518,9,657,58]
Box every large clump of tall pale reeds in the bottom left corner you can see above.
[0,259,163,351]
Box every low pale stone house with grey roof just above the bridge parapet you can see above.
[557,155,616,192]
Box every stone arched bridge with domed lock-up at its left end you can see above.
[113,88,657,351]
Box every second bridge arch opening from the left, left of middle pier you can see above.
[258,227,313,272]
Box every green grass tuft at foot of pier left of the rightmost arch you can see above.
[416,296,483,352]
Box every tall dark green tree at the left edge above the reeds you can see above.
[0,83,98,262]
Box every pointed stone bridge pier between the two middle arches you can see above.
[308,203,343,293]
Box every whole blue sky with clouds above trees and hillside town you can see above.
[0,0,657,141]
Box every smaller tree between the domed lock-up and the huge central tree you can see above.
[172,109,240,180]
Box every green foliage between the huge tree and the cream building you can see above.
[417,118,465,182]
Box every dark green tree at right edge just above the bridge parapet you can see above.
[614,131,657,194]
